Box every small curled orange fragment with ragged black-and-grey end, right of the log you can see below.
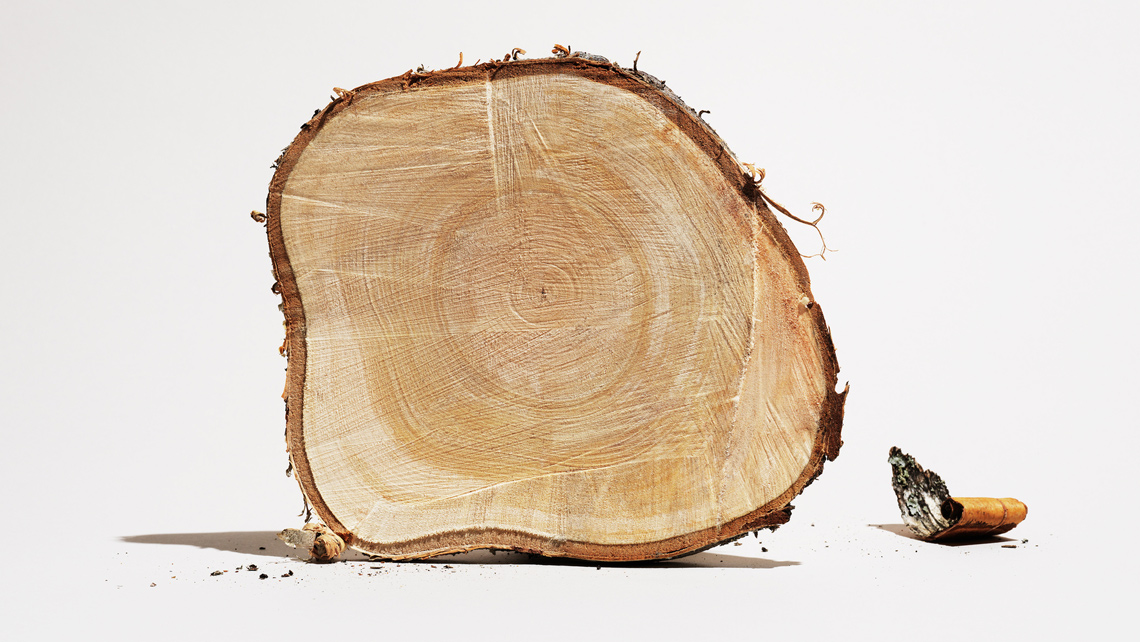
[887,447,1028,542]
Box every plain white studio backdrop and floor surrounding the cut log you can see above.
[0,1,1140,640]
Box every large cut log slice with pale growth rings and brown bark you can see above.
[267,55,846,560]
